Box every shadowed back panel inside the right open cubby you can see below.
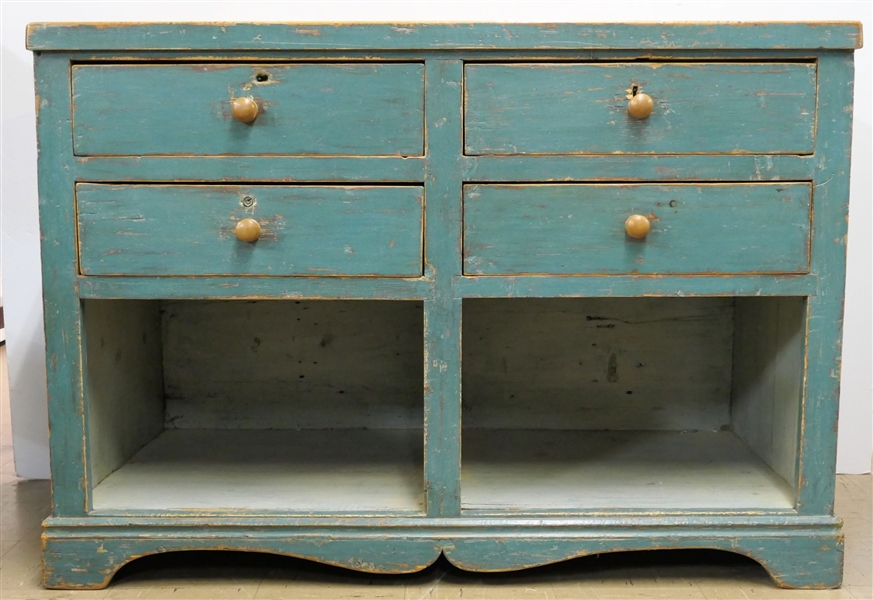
[463,298,734,430]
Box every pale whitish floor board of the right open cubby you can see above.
[461,429,794,511]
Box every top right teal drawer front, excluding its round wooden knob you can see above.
[464,63,816,155]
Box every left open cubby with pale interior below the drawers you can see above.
[83,300,424,514]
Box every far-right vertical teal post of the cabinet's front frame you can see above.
[797,52,852,514]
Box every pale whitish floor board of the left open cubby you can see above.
[93,429,424,513]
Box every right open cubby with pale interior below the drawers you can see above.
[461,297,806,512]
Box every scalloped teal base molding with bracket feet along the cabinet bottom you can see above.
[43,516,843,589]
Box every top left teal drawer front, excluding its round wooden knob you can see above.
[73,63,424,156]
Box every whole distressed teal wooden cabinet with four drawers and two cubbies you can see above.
[28,23,861,589]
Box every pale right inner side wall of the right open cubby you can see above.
[731,297,806,485]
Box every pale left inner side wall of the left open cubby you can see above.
[82,300,164,486]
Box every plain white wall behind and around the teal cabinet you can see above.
[0,0,873,478]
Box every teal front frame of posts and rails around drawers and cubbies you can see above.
[35,49,853,518]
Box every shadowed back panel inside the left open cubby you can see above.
[162,301,424,429]
